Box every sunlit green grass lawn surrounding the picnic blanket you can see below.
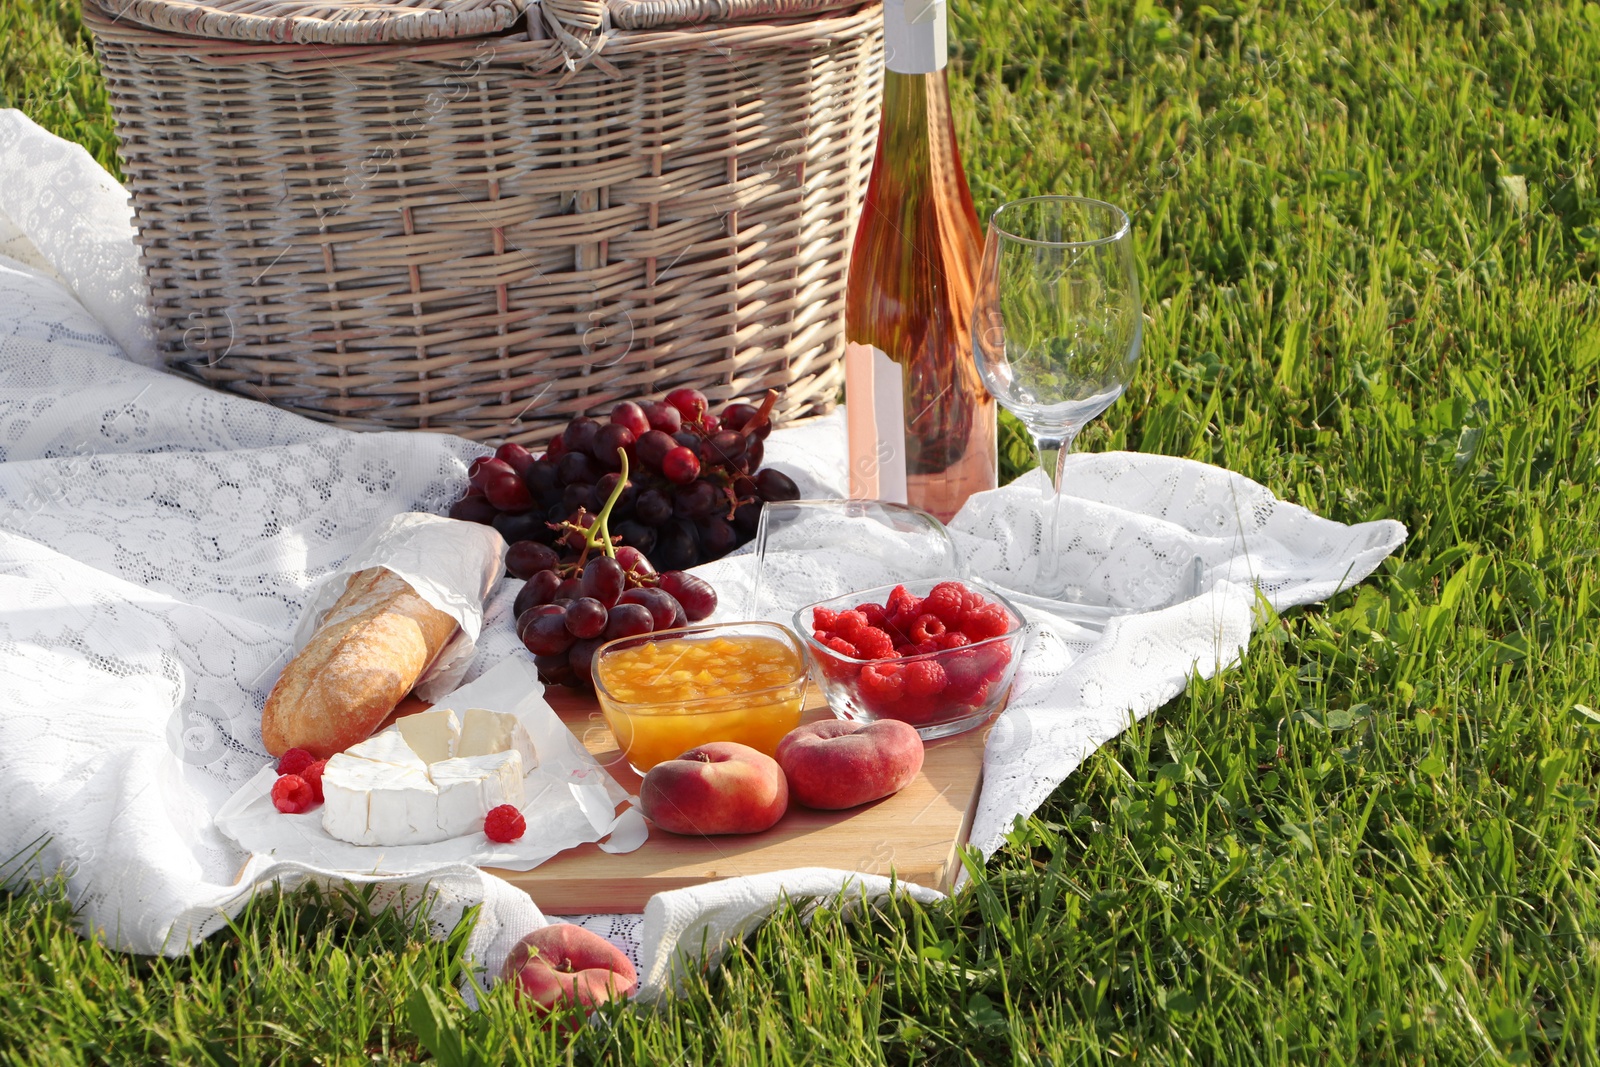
[0,0,1600,1067]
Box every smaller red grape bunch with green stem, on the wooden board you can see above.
[506,450,717,689]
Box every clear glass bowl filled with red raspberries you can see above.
[795,579,1026,741]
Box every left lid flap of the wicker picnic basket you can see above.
[94,0,528,45]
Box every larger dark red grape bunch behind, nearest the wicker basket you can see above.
[450,389,800,571]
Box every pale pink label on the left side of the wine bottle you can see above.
[845,342,907,504]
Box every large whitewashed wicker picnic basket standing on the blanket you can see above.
[85,0,882,443]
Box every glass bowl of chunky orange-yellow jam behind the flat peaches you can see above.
[594,622,806,774]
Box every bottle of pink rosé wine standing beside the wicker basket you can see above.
[845,0,997,520]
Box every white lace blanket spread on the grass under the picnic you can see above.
[0,110,1405,989]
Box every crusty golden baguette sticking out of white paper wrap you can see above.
[261,566,456,760]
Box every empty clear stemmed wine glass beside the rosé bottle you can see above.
[973,197,1144,600]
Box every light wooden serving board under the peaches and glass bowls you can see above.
[491,686,989,915]
